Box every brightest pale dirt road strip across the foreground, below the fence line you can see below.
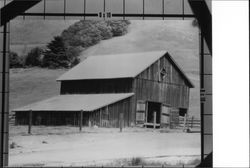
[9,126,200,166]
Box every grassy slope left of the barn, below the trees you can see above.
[10,68,66,109]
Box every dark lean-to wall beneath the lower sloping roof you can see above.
[15,98,131,127]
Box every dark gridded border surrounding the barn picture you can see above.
[0,0,213,167]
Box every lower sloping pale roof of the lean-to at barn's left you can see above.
[13,93,134,112]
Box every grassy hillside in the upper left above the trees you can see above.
[10,20,77,56]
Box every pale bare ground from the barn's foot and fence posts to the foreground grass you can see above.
[9,126,200,166]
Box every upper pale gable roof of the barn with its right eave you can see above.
[57,51,193,87]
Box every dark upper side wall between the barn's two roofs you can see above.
[61,78,132,94]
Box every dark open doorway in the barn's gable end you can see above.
[147,102,161,124]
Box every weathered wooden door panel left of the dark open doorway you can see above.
[136,100,146,124]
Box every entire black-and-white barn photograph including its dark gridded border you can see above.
[0,0,248,168]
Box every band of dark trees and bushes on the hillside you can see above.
[9,20,130,69]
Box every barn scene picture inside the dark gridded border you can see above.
[9,20,200,166]
